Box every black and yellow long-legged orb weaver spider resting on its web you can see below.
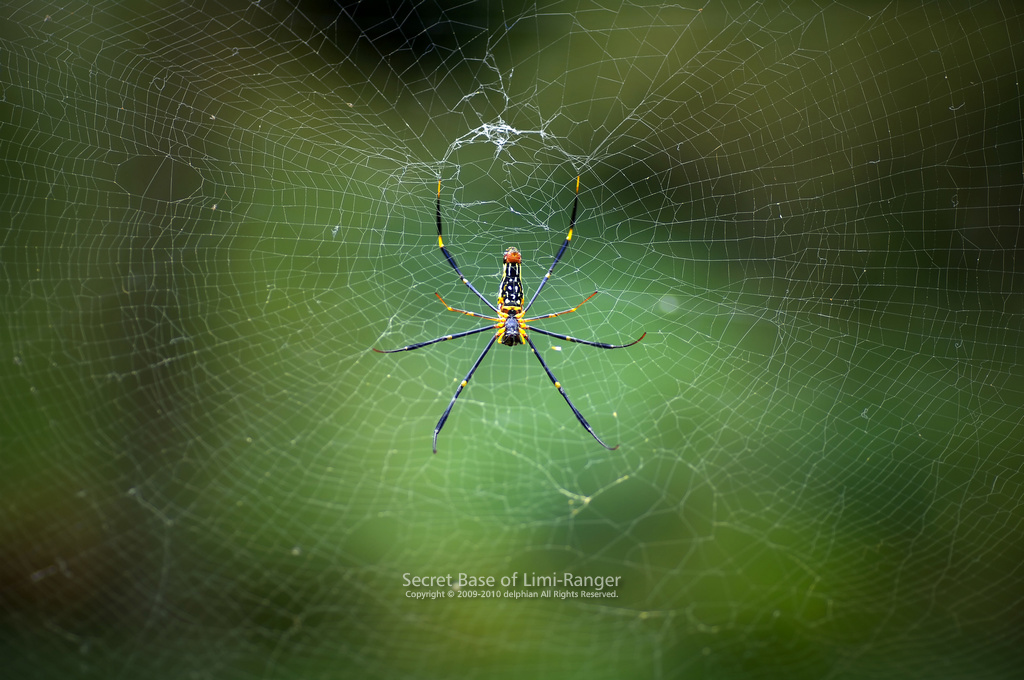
[373,177,647,454]
